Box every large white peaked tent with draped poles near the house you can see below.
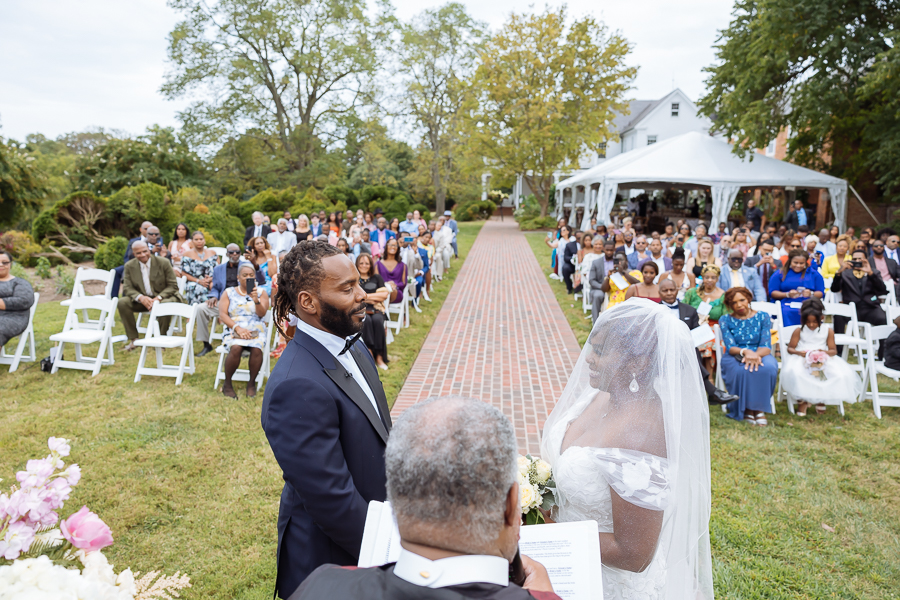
[556,132,847,231]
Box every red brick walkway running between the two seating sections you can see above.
[391,219,580,454]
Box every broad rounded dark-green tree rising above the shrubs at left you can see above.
[74,126,206,194]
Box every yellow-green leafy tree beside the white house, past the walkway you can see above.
[466,7,637,217]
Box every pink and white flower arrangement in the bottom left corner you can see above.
[0,437,191,600]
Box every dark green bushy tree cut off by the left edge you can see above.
[0,138,47,225]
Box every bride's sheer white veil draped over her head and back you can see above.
[541,299,713,600]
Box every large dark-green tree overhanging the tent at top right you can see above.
[699,0,900,192]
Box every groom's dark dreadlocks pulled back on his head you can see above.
[272,240,341,339]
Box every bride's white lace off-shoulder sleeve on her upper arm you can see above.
[594,448,670,510]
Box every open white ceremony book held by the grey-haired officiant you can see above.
[358,501,603,600]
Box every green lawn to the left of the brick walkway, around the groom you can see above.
[0,223,481,600]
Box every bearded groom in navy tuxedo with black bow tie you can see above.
[262,241,391,598]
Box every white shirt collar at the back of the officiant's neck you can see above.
[394,549,509,588]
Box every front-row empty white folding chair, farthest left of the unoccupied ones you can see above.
[50,297,117,375]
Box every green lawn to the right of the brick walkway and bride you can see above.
[527,233,900,599]
